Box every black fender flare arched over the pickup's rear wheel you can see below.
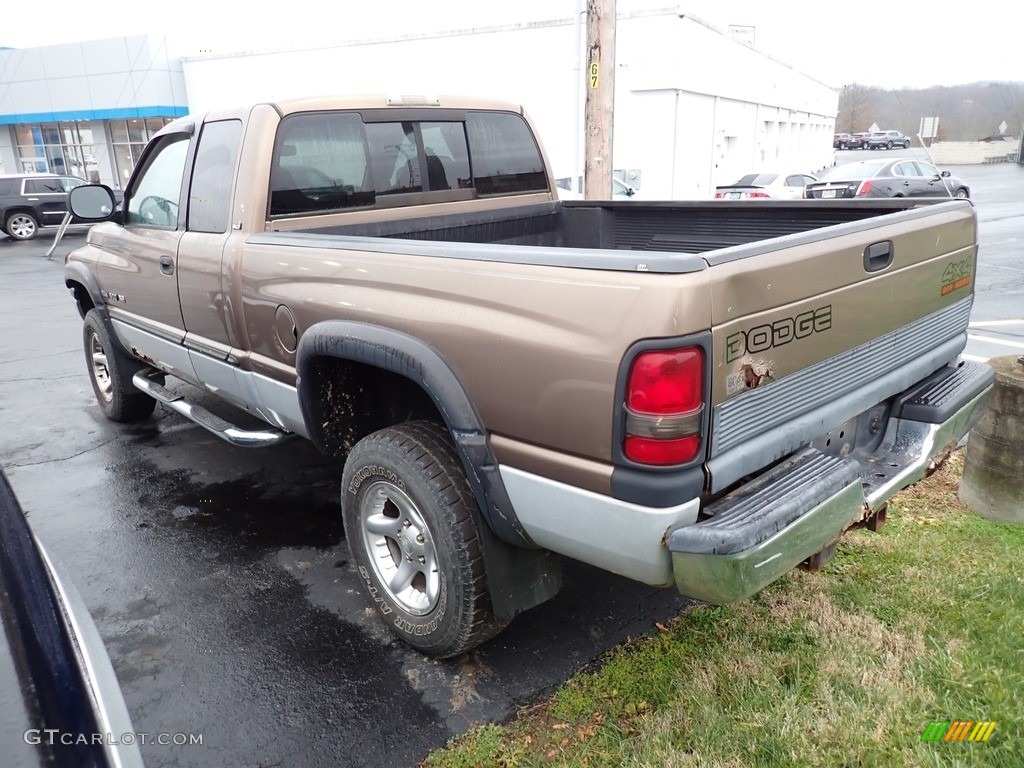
[295,321,536,547]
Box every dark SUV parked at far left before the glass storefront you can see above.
[0,173,85,240]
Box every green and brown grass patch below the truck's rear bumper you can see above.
[425,455,1024,768]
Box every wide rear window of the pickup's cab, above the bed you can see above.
[268,110,550,218]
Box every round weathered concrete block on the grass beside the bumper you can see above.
[958,355,1024,523]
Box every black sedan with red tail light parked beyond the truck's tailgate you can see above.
[807,158,971,200]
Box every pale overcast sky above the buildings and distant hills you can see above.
[0,0,1024,90]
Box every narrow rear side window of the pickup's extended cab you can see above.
[188,120,242,233]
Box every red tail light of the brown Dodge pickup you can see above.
[623,346,705,466]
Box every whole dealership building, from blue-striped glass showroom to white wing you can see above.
[0,8,838,199]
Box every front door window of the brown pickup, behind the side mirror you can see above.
[125,133,188,229]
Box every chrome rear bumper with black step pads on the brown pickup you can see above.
[668,364,994,603]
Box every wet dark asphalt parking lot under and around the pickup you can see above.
[0,165,1024,768]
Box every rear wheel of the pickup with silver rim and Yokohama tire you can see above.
[341,421,506,658]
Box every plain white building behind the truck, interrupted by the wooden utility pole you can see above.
[183,8,839,199]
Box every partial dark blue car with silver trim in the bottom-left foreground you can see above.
[0,471,142,768]
